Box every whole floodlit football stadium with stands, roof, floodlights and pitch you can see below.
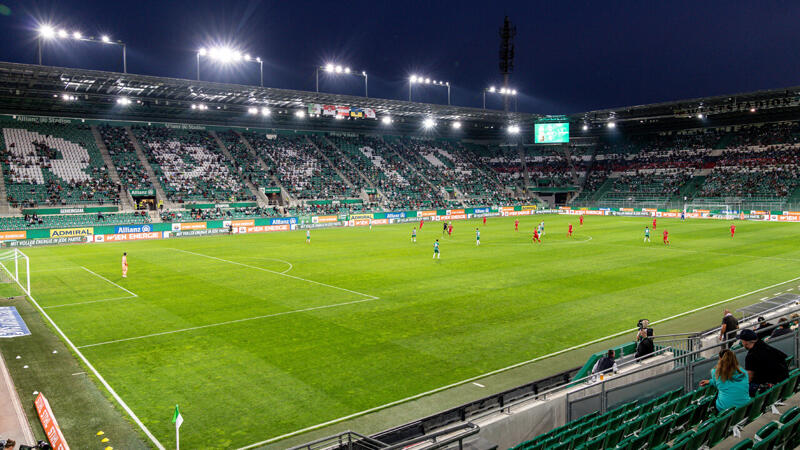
[0,2,800,450]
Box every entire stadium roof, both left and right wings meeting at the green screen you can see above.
[0,62,800,139]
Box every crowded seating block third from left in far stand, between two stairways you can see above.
[133,126,254,203]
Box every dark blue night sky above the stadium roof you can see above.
[0,0,800,114]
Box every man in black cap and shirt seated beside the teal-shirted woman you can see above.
[739,330,789,397]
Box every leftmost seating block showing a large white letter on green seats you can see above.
[0,123,120,207]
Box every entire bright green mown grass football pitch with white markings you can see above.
[17,215,800,448]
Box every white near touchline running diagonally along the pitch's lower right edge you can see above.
[238,277,800,450]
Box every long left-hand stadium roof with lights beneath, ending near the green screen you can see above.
[0,62,539,138]
